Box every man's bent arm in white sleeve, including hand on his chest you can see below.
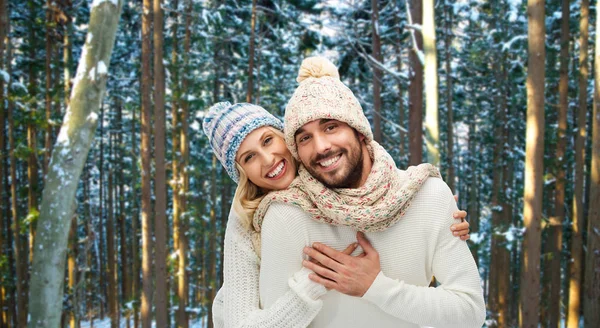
[304,181,485,327]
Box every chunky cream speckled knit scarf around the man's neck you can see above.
[253,141,441,236]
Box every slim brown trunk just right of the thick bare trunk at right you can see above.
[547,0,570,328]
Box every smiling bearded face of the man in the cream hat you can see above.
[295,119,364,188]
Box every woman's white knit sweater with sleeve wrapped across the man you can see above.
[212,210,326,328]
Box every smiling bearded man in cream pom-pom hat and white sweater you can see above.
[255,58,485,327]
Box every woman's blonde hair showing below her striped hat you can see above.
[233,126,284,231]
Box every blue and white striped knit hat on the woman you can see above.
[202,102,283,183]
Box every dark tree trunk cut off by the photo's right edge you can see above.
[584,1,600,327]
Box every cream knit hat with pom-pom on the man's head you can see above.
[284,57,373,159]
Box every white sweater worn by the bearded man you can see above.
[260,179,486,328]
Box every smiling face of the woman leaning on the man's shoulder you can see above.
[236,126,296,191]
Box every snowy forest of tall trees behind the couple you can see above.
[0,0,600,328]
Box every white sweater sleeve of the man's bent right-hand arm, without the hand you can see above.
[363,191,485,327]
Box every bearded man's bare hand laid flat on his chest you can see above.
[302,232,381,297]
